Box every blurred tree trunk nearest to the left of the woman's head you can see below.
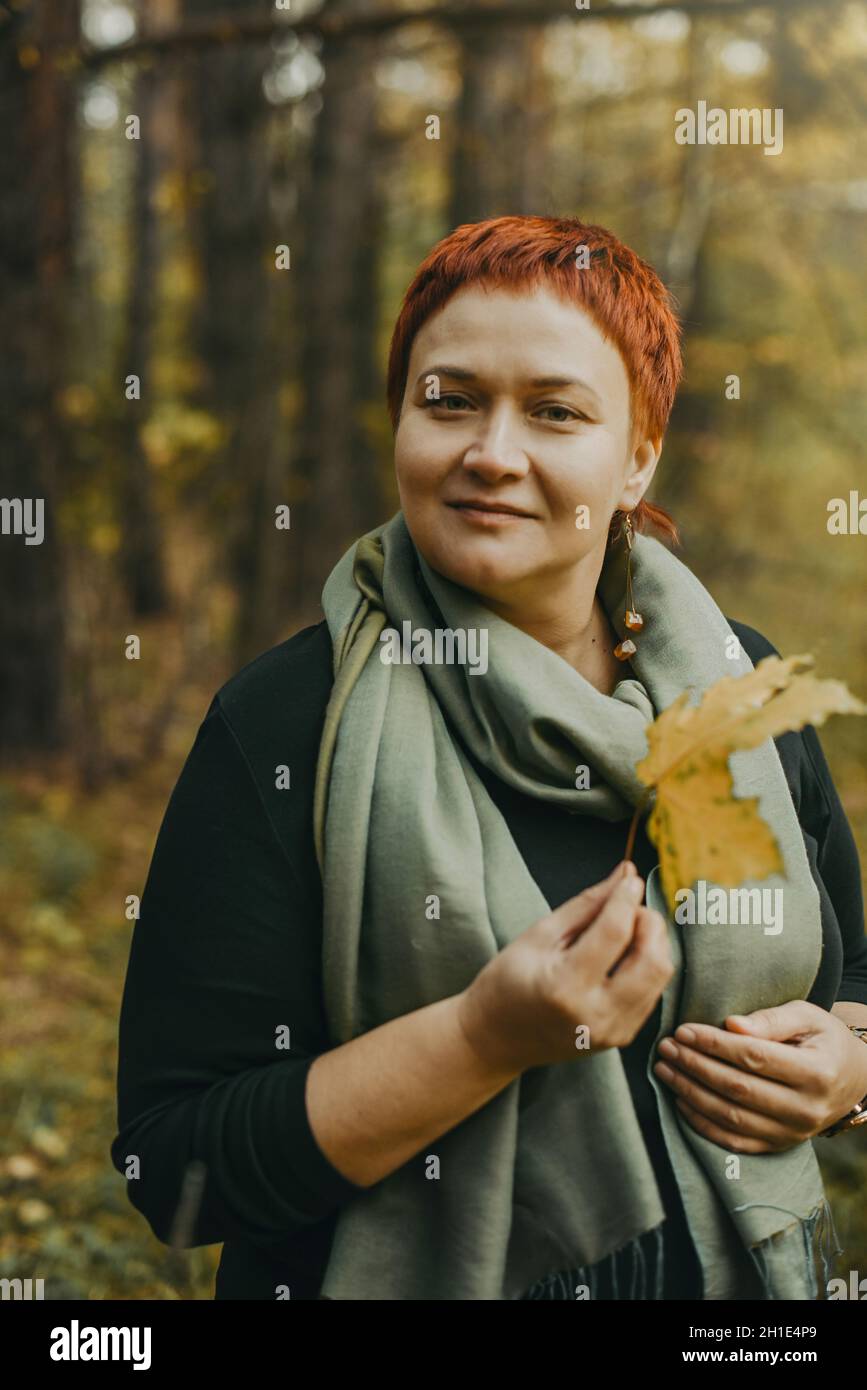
[293,0,383,619]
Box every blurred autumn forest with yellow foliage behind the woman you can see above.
[0,0,867,1298]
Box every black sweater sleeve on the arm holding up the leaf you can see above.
[111,698,364,1247]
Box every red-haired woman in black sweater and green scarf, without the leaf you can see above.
[111,217,867,1300]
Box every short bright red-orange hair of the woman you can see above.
[386,217,684,541]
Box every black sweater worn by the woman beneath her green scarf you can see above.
[111,620,867,1298]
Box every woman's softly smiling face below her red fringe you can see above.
[395,285,659,613]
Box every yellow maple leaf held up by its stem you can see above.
[635,655,867,912]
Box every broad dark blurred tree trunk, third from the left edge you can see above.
[185,0,287,664]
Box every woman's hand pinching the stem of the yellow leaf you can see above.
[459,860,674,1073]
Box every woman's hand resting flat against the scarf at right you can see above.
[653,999,867,1154]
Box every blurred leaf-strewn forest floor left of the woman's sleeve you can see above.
[0,614,225,1300]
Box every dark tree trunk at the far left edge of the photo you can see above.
[0,0,79,758]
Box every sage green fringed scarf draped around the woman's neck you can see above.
[314,512,831,1300]
